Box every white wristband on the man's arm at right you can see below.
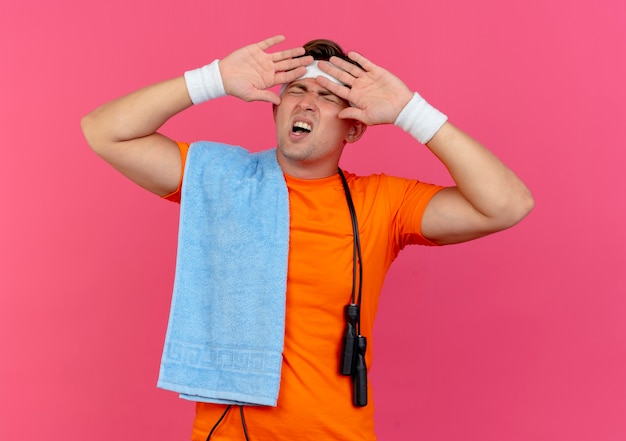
[394,92,448,144]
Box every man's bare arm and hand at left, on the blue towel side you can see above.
[81,36,312,196]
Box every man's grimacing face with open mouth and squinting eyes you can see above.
[274,78,363,178]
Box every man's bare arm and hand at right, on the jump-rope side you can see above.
[318,52,534,244]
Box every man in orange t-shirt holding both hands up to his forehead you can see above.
[82,36,533,440]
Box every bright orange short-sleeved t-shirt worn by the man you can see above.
[166,144,442,441]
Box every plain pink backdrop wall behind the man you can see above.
[0,0,626,441]
